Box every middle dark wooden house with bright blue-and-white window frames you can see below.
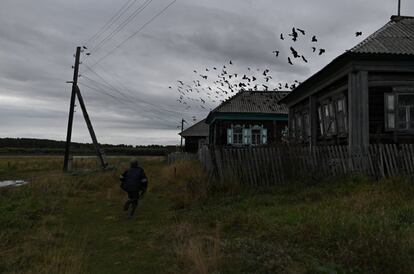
[206,90,288,146]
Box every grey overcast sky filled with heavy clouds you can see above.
[0,0,414,145]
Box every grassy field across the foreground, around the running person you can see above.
[0,157,414,273]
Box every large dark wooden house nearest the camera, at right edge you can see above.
[281,16,414,147]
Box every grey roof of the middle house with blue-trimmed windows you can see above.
[209,90,289,116]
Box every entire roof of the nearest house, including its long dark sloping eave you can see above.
[281,16,414,104]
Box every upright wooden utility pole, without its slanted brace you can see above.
[63,47,81,171]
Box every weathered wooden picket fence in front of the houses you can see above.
[198,144,414,185]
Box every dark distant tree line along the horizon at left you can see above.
[0,138,177,156]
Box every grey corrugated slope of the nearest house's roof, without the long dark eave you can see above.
[349,16,414,55]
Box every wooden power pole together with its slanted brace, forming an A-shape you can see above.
[63,47,108,171]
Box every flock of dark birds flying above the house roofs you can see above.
[169,27,362,120]
